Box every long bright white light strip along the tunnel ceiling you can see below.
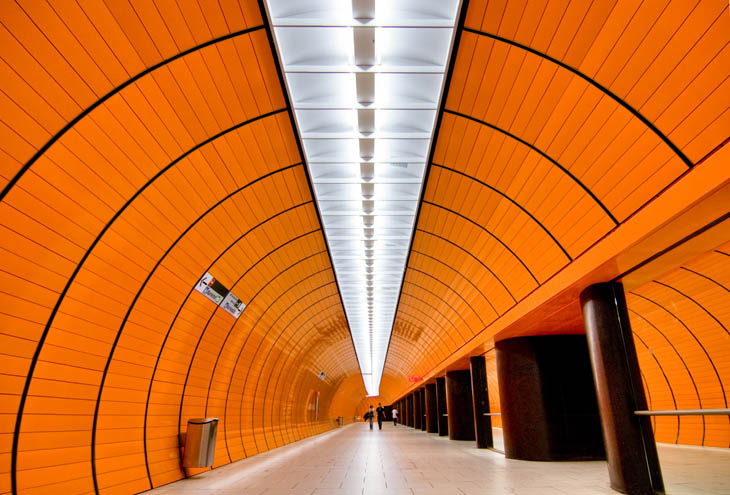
[268,0,460,395]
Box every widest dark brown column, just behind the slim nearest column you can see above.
[495,335,605,461]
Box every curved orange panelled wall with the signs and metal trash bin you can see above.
[0,1,364,493]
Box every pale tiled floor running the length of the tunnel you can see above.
[148,423,730,495]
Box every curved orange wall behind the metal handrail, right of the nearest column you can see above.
[626,244,730,447]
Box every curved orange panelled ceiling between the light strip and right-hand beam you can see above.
[384,0,730,416]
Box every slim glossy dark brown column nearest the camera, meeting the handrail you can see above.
[580,283,664,495]
